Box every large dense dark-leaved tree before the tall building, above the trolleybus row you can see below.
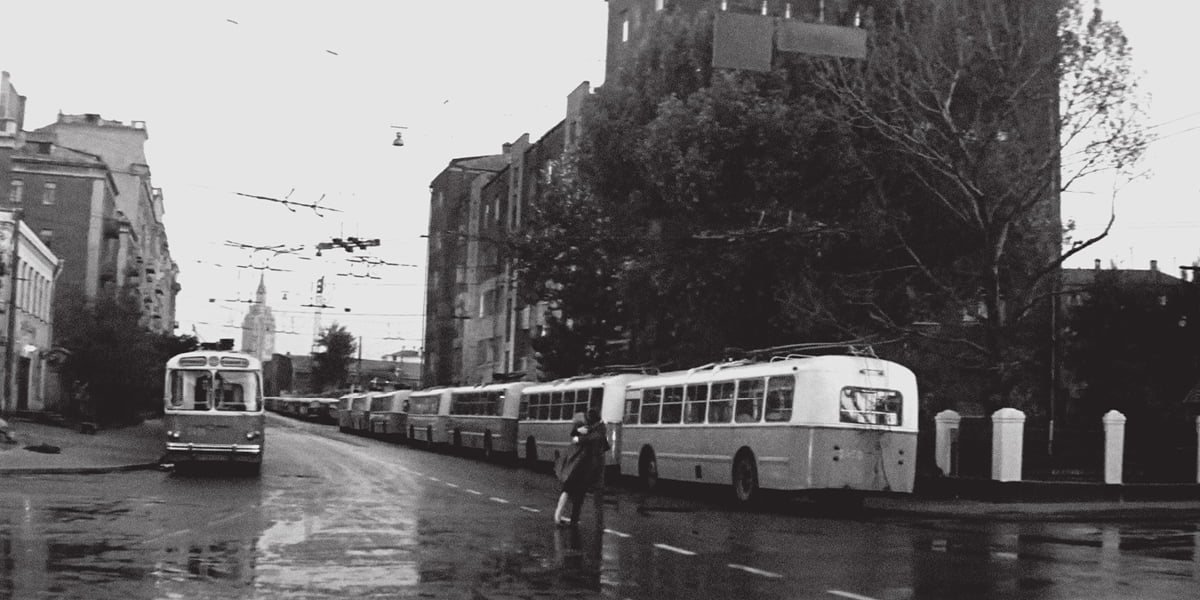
[517,12,851,372]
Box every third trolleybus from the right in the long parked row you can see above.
[445,382,530,458]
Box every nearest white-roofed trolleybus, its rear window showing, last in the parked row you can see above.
[620,355,917,504]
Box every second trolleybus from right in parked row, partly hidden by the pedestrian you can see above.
[517,373,647,470]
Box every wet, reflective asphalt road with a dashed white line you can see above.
[0,416,1200,600]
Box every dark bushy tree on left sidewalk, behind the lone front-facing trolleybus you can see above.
[54,298,199,424]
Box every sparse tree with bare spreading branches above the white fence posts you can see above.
[820,0,1146,408]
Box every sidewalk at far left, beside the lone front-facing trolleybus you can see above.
[0,419,164,476]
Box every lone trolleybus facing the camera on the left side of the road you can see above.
[163,350,265,473]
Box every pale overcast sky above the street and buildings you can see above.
[0,0,1200,358]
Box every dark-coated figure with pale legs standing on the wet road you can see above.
[554,408,611,527]
